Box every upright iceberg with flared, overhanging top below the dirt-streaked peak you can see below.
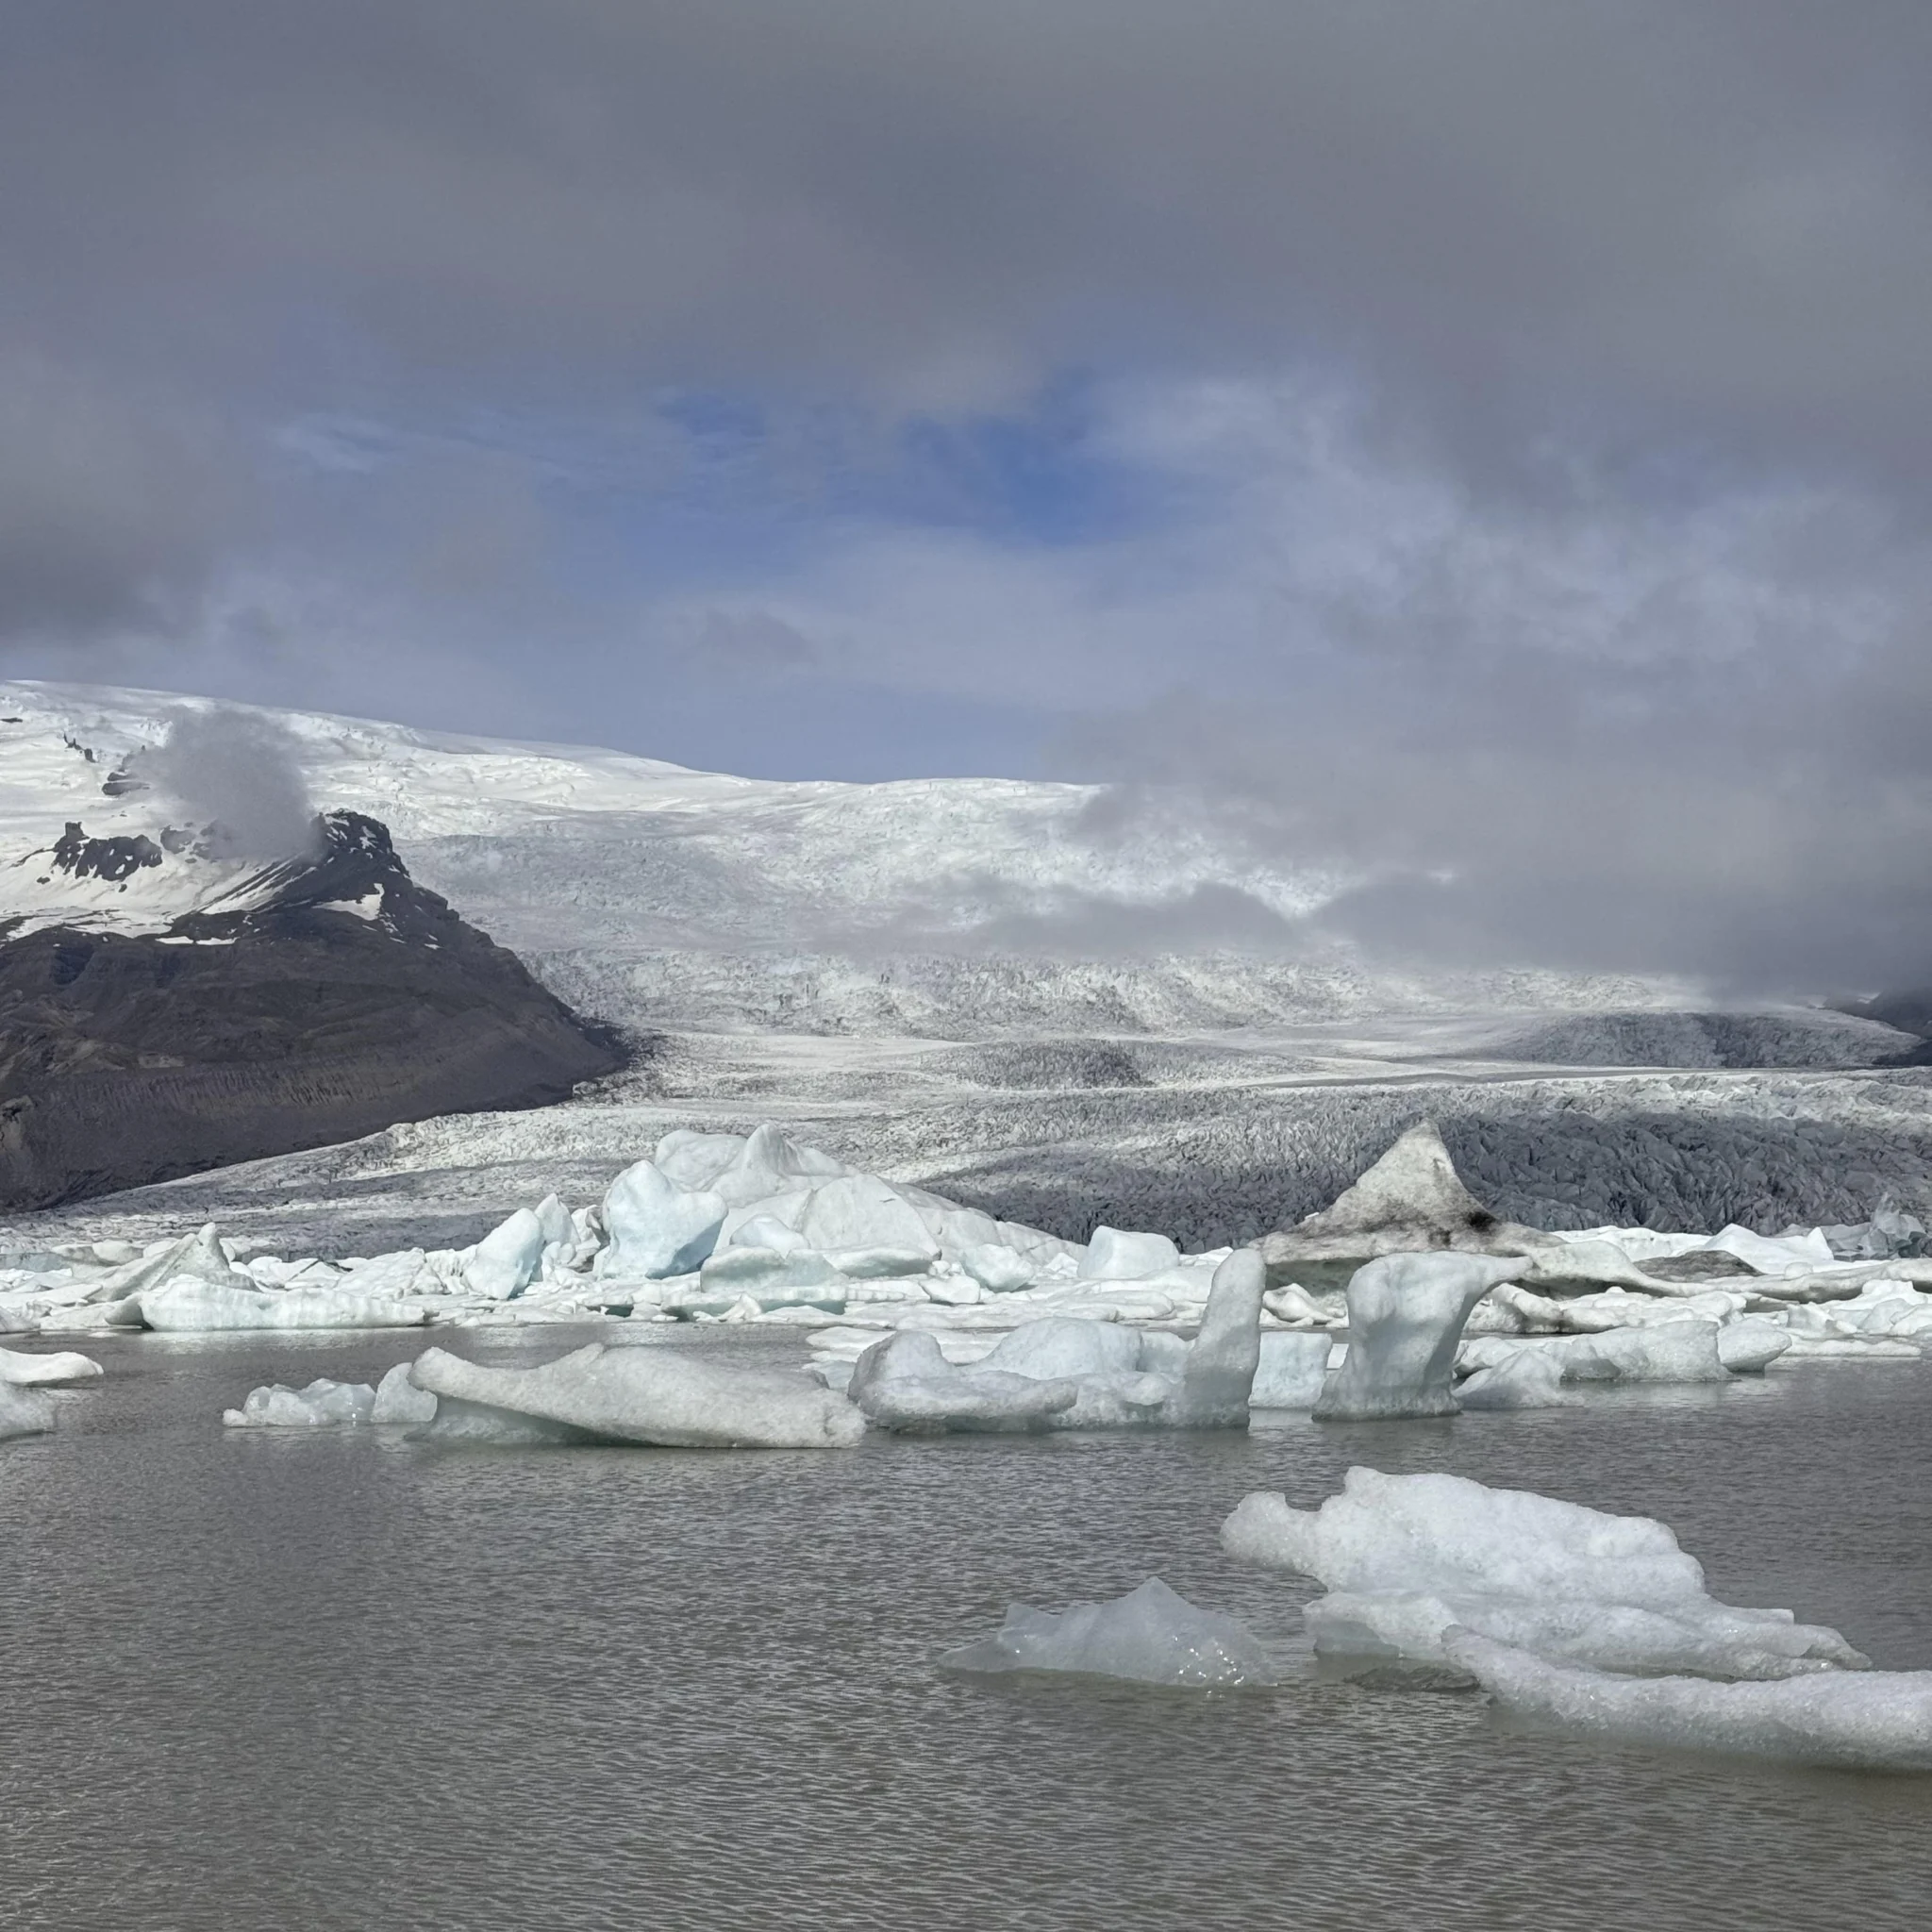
[1314,1252,1530,1422]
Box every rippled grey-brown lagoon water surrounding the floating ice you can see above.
[0,1329,1932,1932]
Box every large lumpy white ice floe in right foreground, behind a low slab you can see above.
[1221,1468,1866,1677]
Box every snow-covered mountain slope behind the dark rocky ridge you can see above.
[0,684,1696,1038]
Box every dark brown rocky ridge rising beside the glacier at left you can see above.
[0,811,626,1209]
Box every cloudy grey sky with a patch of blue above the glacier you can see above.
[0,0,1932,990]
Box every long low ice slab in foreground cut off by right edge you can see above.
[1443,1628,1932,1772]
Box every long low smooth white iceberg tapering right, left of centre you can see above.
[409,1342,866,1449]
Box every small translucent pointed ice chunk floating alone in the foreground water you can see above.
[939,1576,1281,1690]
